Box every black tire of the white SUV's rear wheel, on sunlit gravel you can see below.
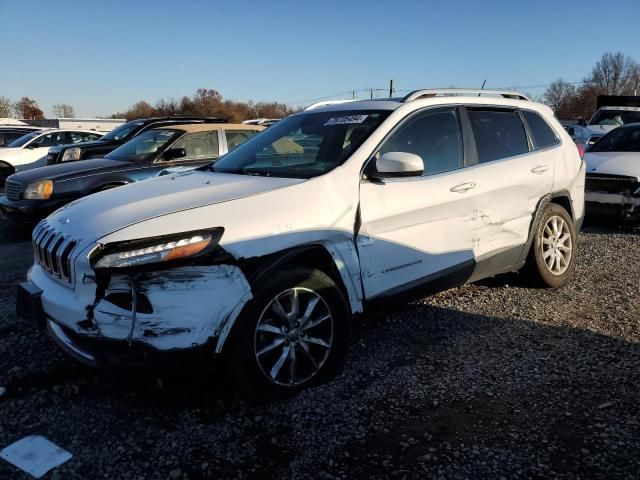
[525,203,577,288]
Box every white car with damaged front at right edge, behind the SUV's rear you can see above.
[584,123,640,220]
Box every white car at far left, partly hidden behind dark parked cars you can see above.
[0,129,102,183]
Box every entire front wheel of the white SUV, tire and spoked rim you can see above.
[229,267,349,399]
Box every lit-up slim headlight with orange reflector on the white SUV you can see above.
[92,228,224,270]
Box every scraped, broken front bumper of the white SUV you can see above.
[16,264,252,366]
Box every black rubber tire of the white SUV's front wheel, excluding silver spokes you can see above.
[226,266,350,400]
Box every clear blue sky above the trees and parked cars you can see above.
[0,0,640,116]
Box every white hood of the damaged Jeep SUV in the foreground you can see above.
[47,171,304,243]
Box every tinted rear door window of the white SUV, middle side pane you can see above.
[468,110,529,163]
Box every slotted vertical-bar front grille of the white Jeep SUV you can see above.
[32,220,78,283]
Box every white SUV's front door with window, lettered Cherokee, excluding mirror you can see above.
[357,108,474,299]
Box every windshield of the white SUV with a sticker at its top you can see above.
[212,110,390,178]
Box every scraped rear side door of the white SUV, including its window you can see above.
[467,107,554,270]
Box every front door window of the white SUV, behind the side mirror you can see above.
[380,110,462,175]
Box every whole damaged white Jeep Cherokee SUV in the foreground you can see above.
[18,90,585,397]
